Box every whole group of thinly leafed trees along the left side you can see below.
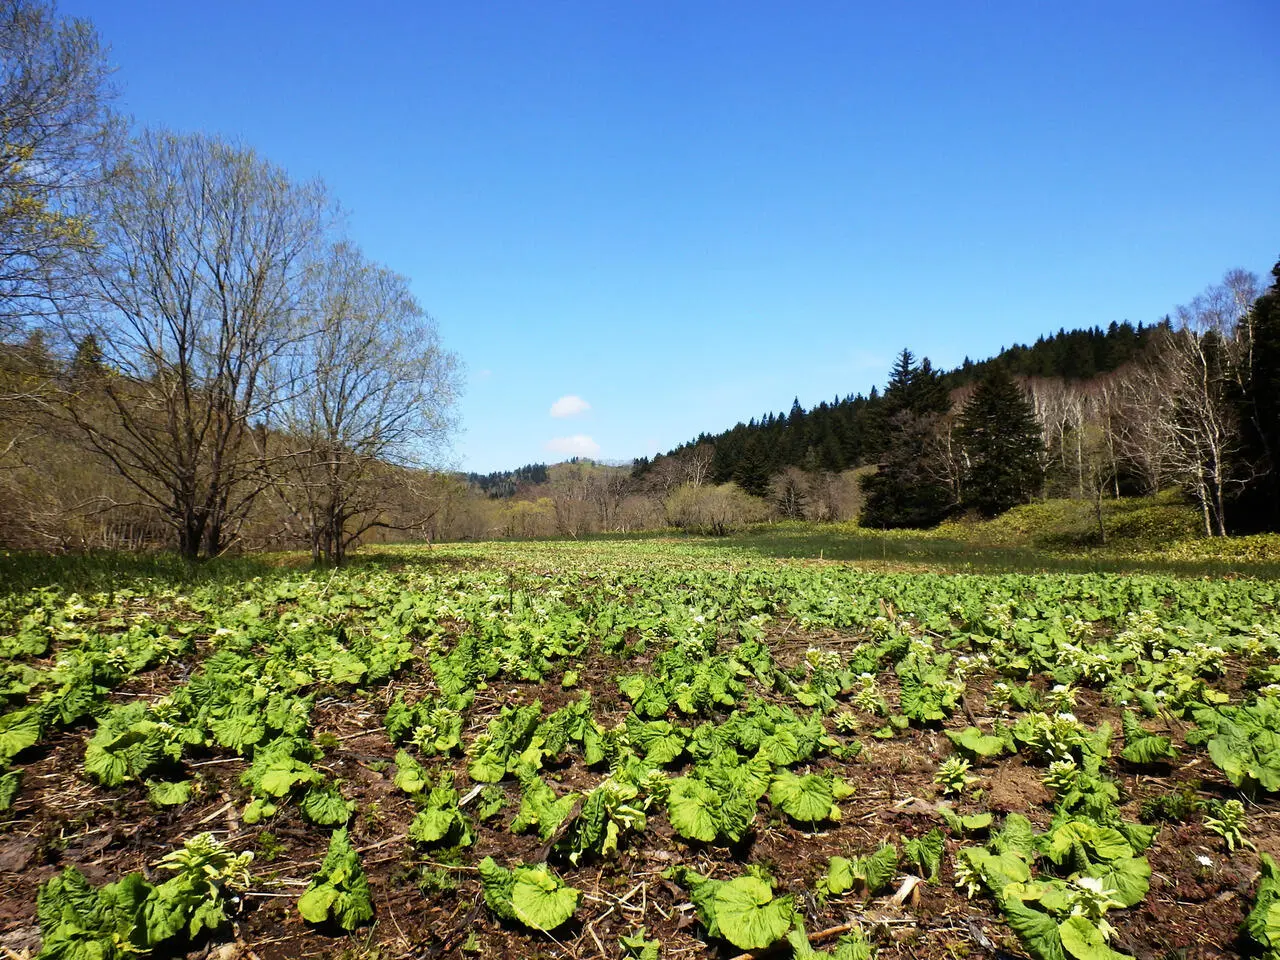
[0,0,458,561]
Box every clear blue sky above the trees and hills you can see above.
[60,0,1280,471]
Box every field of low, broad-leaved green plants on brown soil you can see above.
[0,540,1280,960]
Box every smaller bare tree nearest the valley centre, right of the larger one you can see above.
[271,243,458,563]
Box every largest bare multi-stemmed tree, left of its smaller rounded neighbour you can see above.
[55,132,328,558]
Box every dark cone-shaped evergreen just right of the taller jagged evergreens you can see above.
[959,366,1043,516]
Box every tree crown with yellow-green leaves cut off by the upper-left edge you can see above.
[0,0,120,338]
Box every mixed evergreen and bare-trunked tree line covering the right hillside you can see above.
[635,264,1280,538]
